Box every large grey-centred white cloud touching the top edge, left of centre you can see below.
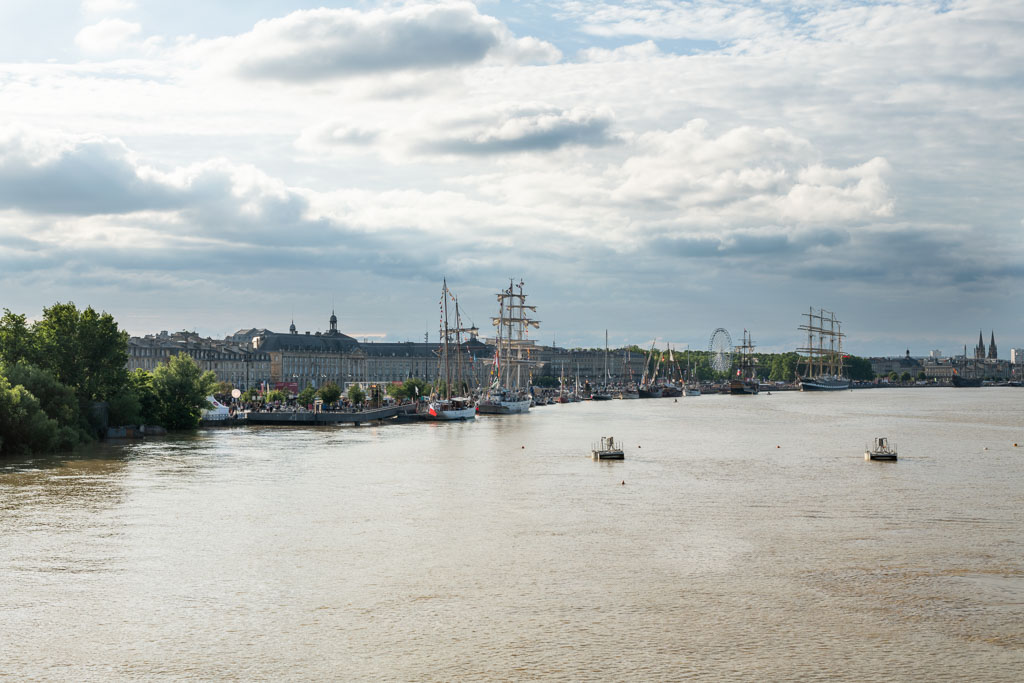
[214,2,561,83]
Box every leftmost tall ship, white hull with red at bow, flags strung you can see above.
[420,280,476,421]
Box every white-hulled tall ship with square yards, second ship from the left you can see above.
[476,281,541,415]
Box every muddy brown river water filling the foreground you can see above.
[0,388,1024,681]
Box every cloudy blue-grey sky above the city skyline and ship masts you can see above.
[0,0,1024,357]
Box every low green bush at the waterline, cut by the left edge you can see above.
[0,376,79,455]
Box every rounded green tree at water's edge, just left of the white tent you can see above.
[153,353,217,429]
